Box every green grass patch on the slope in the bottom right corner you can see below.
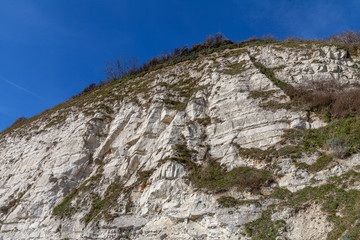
[266,170,360,240]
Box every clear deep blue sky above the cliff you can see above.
[0,0,360,131]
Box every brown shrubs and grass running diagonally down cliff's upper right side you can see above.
[249,55,360,161]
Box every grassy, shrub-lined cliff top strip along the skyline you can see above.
[0,32,359,139]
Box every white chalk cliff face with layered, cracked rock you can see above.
[0,44,360,240]
